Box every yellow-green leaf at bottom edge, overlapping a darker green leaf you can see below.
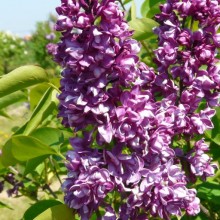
[35,204,75,220]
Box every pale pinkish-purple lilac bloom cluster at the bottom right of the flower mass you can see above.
[121,160,200,219]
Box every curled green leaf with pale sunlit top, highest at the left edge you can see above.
[0,66,48,97]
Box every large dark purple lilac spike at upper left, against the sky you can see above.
[55,0,144,143]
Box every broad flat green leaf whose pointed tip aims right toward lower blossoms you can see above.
[2,135,57,165]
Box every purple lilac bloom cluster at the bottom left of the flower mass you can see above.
[63,143,114,219]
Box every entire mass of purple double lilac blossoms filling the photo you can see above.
[51,0,220,220]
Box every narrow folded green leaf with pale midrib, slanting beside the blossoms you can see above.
[15,88,58,135]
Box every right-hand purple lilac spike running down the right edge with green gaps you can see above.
[155,0,220,180]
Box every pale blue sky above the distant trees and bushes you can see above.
[0,0,143,36]
